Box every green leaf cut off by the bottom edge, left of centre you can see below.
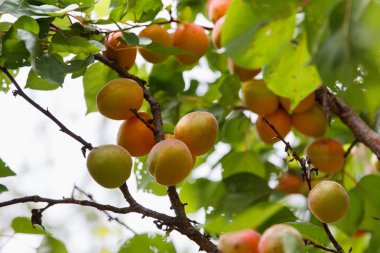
[118,234,176,253]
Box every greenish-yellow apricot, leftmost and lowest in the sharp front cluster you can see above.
[87,145,132,188]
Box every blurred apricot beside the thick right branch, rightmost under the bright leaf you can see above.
[292,104,328,138]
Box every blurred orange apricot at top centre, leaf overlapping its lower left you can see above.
[173,23,208,65]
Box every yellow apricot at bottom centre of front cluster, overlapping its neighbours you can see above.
[147,139,193,186]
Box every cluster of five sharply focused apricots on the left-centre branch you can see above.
[87,78,218,188]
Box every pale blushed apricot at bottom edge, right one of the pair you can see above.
[259,224,304,253]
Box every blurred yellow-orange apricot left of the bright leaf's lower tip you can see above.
[242,79,279,115]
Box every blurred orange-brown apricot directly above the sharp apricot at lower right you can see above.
[306,138,344,174]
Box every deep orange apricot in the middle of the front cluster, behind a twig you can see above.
[116,112,156,157]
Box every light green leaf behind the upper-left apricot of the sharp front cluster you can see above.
[83,62,118,114]
